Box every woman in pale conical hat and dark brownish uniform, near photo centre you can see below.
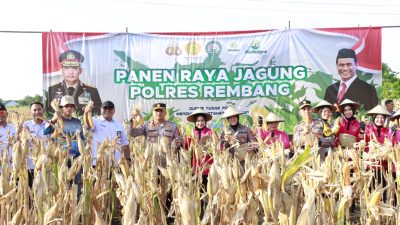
[220,106,257,158]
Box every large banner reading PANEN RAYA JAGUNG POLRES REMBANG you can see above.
[43,27,382,130]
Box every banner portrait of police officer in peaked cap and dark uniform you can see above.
[47,50,101,115]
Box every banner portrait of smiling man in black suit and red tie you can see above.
[324,48,378,110]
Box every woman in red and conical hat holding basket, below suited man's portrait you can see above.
[335,99,361,148]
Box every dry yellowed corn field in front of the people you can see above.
[0,106,400,225]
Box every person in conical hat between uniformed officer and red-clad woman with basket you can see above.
[313,100,338,161]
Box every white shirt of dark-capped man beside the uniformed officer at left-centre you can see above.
[92,116,129,165]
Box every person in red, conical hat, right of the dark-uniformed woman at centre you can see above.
[257,112,291,149]
